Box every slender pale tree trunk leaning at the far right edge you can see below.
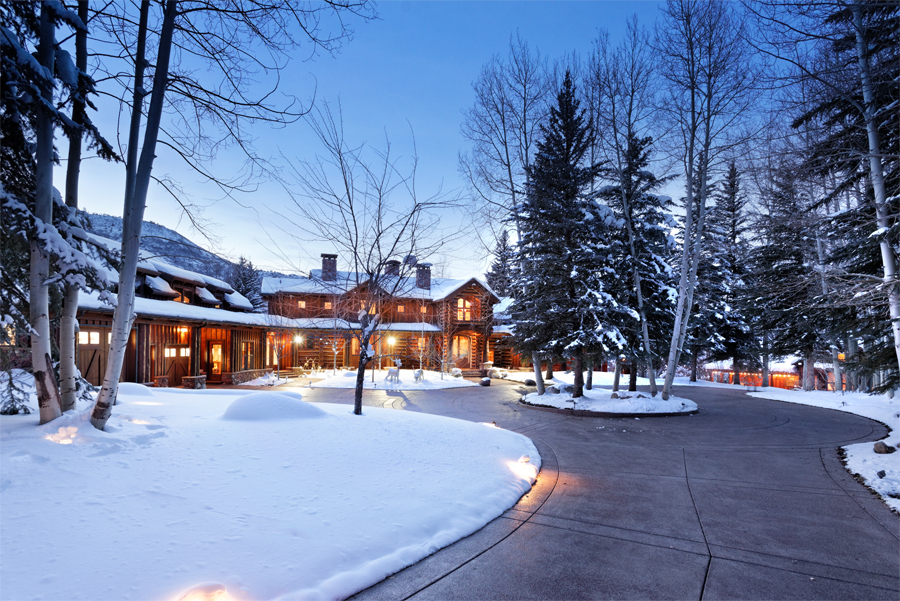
[850,3,900,380]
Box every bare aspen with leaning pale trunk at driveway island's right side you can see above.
[655,0,758,400]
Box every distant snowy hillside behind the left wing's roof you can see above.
[82,212,286,280]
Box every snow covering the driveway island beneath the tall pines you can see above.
[523,387,697,415]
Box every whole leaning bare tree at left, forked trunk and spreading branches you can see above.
[91,0,371,429]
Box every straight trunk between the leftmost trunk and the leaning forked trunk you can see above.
[59,0,88,411]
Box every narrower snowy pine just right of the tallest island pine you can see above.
[600,134,675,395]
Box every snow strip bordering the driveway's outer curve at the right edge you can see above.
[748,387,900,511]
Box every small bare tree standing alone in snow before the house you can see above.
[282,103,456,415]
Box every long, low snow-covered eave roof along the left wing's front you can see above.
[78,292,358,330]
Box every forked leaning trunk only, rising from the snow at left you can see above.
[91,0,178,430]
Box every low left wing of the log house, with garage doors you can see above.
[76,235,349,387]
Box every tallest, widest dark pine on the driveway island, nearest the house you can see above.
[510,71,631,398]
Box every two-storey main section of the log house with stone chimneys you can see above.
[261,254,502,372]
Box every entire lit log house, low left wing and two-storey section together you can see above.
[77,244,509,388]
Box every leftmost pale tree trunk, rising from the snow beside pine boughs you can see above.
[28,3,62,424]
